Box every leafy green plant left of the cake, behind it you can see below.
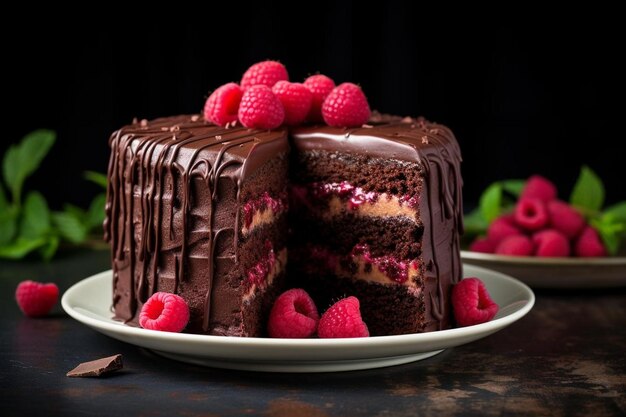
[0,129,106,260]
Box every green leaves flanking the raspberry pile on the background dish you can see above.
[463,165,626,255]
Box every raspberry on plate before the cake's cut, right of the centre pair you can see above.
[317,297,370,338]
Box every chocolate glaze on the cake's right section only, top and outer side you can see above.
[291,114,463,330]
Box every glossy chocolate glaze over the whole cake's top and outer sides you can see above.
[104,115,462,334]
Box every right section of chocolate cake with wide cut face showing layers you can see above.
[289,115,462,336]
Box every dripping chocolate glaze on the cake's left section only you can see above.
[104,115,289,332]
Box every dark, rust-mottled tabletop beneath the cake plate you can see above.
[0,250,626,417]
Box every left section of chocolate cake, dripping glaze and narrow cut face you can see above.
[104,116,289,336]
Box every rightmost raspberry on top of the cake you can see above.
[322,83,371,127]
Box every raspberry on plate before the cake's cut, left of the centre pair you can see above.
[267,288,320,338]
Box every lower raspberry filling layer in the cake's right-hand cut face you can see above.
[294,244,419,286]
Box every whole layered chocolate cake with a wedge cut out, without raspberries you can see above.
[105,115,462,336]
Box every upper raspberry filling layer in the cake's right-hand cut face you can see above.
[290,181,419,219]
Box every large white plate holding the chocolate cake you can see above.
[61,265,535,372]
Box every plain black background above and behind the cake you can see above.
[0,7,626,208]
